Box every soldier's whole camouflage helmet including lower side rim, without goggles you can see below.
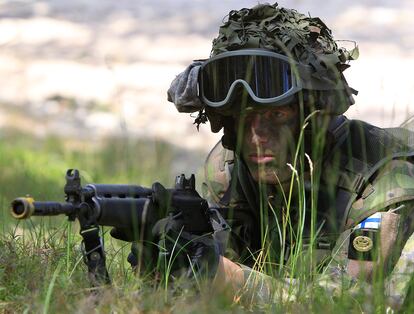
[205,3,358,148]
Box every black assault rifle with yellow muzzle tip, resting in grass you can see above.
[11,169,220,286]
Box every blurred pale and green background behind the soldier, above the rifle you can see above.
[0,0,414,202]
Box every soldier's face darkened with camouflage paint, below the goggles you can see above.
[236,105,299,184]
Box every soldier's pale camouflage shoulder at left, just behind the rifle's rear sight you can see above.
[203,141,234,203]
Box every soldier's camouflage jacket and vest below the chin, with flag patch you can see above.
[203,116,414,308]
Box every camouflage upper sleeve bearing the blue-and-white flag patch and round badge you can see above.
[340,159,414,278]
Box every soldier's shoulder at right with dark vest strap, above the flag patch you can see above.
[336,120,414,228]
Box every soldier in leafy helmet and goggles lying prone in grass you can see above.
[168,4,414,308]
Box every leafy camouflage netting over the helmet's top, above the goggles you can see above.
[211,3,358,80]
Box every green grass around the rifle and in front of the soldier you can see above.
[0,126,412,313]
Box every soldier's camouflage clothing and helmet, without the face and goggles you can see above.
[168,3,414,308]
